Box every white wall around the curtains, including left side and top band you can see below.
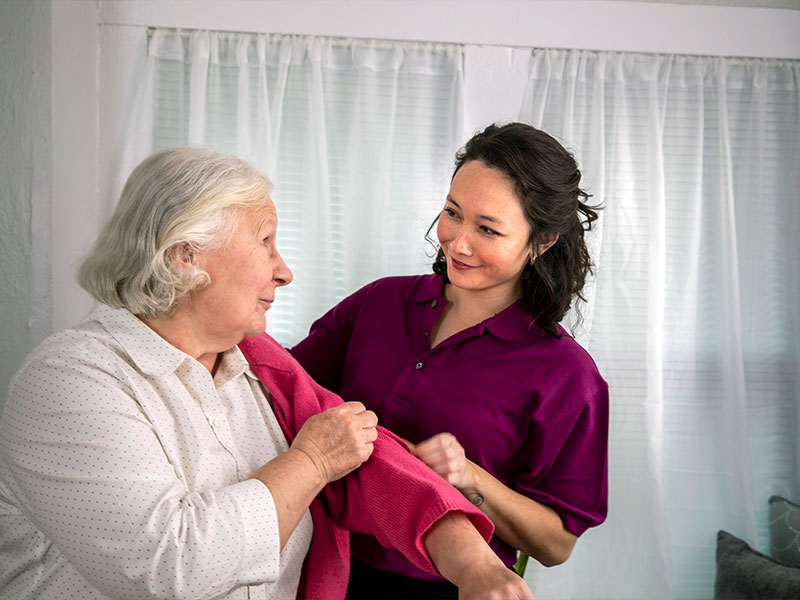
[0,0,800,402]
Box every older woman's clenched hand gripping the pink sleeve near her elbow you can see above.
[291,402,378,483]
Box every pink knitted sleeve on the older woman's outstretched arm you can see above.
[239,334,494,573]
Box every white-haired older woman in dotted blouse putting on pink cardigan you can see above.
[0,149,531,600]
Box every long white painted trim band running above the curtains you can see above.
[99,0,800,59]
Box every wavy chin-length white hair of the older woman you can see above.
[78,148,273,317]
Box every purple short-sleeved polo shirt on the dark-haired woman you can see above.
[291,275,608,579]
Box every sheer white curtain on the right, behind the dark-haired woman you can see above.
[520,50,800,599]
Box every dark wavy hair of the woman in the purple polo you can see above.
[426,123,599,337]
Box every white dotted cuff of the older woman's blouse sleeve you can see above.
[228,479,281,585]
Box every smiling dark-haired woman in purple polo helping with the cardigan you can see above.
[292,123,608,598]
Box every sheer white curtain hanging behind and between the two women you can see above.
[118,29,463,345]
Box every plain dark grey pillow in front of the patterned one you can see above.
[714,530,800,600]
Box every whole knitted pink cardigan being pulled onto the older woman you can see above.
[239,334,493,600]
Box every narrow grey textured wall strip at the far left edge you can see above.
[0,1,52,408]
